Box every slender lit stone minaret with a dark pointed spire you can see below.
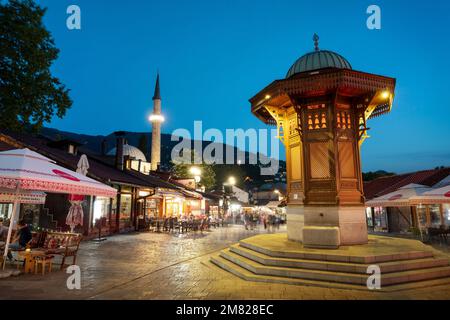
[149,72,164,171]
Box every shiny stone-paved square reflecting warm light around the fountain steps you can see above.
[0,226,450,300]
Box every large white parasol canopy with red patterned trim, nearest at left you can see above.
[0,149,117,198]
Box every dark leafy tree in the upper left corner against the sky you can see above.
[0,0,72,131]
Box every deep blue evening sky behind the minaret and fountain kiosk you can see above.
[39,0,450,172]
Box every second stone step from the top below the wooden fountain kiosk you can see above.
[230,244,449,274]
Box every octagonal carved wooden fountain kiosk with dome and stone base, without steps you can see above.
[250,35,395,248]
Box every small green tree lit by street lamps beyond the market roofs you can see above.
[171,150,216,190]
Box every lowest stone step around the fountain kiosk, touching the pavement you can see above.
[210,253,450,292]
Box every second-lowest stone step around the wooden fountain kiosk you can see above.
[220,249,450,286]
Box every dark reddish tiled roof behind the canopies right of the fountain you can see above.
[364,167,450,200]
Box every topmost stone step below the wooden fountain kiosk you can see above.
[239,240,433,264]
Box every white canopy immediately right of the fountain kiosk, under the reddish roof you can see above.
[366,183,431,207]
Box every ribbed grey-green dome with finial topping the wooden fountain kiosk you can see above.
[286,35,352,78]
